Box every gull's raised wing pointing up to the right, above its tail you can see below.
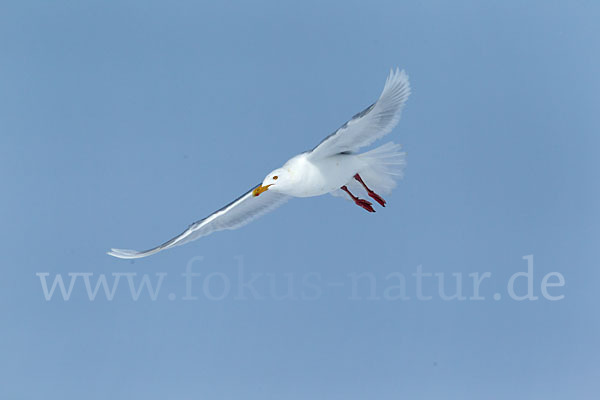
[309,69,410,159]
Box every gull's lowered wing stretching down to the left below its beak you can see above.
[107,185,289,258]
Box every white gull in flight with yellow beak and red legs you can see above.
[107,68,411,259]
